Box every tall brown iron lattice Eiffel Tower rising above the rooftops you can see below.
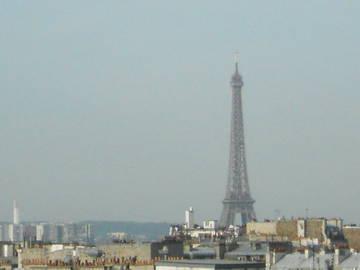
[220,62,256,227]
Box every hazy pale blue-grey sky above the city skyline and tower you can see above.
[0,0,360,223]
